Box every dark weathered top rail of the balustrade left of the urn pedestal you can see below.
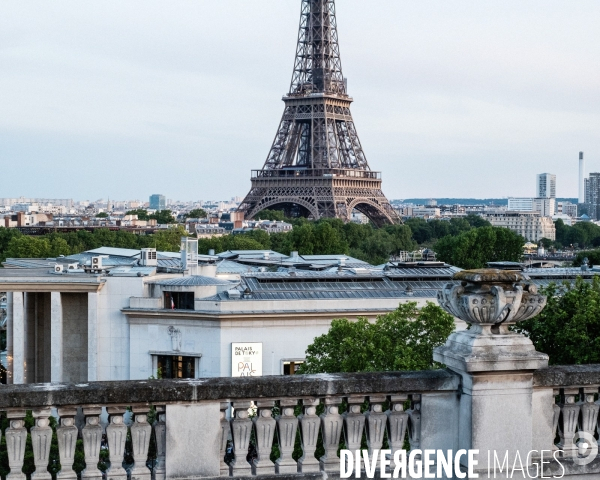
[0,370,460,410]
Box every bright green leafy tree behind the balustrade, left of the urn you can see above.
[300,302,454,373]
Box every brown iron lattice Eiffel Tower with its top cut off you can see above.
[239,0,400,226]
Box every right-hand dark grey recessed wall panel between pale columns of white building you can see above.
[61,293,88,382]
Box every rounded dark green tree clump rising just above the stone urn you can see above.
[434,227,525,269]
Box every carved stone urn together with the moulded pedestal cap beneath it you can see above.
[434,268,548,372]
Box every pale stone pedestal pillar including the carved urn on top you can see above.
[434,269,548,478]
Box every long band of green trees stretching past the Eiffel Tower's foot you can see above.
[0,211,524,268]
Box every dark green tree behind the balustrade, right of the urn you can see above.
[515,276,600,365]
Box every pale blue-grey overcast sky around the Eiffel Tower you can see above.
[0,0,600,200]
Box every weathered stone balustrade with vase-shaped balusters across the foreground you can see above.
[0,365,600,480]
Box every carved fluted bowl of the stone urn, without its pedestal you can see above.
[438,268,546,325]
